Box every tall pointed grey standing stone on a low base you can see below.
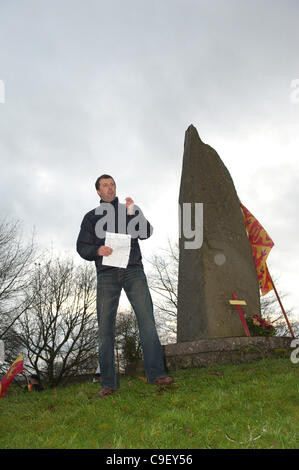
[177,125,260,343]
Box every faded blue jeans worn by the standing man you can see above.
[97,266,166,389]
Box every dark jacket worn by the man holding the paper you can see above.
[77,197,153,273]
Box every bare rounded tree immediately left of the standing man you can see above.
[17,258,98,387]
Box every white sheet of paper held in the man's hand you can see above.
[102,232,131,268]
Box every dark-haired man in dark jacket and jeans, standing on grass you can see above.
[77,174,173,397]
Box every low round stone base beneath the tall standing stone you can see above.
[163,336,292,370]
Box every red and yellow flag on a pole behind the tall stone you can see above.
[241,204,274,295]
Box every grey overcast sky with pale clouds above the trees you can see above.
[0,0,299,315]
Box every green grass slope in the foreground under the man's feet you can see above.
[0,359,299,449]
